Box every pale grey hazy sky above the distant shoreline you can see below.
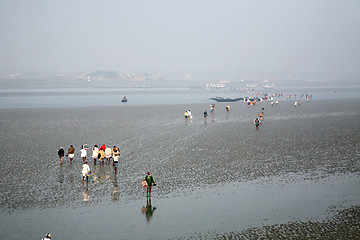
[0,0,360,78]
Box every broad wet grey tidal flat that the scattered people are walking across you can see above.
[0,99,360,239]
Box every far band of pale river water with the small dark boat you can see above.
[0,86,360,109]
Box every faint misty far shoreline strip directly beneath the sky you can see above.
[0,70,360,81]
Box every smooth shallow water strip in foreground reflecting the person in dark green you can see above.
[0,174,360,239]
